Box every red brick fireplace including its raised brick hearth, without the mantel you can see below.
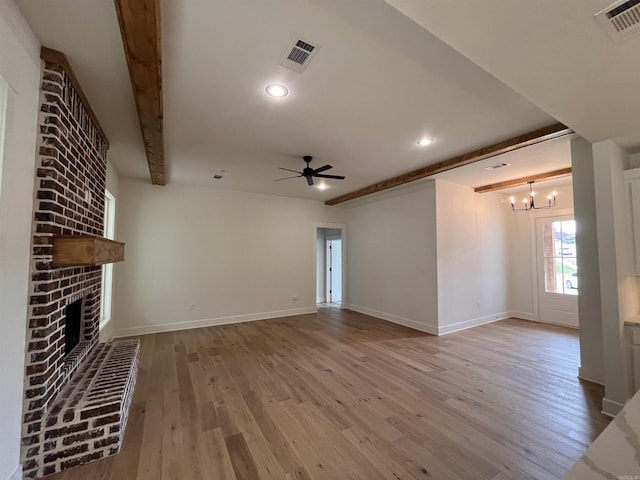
[22,48,138,478]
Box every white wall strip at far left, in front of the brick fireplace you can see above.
[0,1,40,479]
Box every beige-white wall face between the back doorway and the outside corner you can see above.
[347,180,438,334]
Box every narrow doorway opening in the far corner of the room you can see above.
[316,227,344,305]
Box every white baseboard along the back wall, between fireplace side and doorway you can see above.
[113,307,317,338]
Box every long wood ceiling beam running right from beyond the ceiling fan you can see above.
[324,123,573,205]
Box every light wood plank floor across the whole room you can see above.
[48,308,608,480]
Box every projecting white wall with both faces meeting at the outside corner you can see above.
[347,180,512,334]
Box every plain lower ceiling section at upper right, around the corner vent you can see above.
[387,0,640,153]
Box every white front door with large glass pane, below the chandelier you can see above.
[536,216,579,327]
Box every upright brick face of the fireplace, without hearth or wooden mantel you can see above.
[23,56,107,471]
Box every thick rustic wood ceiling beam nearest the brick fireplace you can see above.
[115,0,165,185]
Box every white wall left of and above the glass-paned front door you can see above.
[502,183,582,320]
